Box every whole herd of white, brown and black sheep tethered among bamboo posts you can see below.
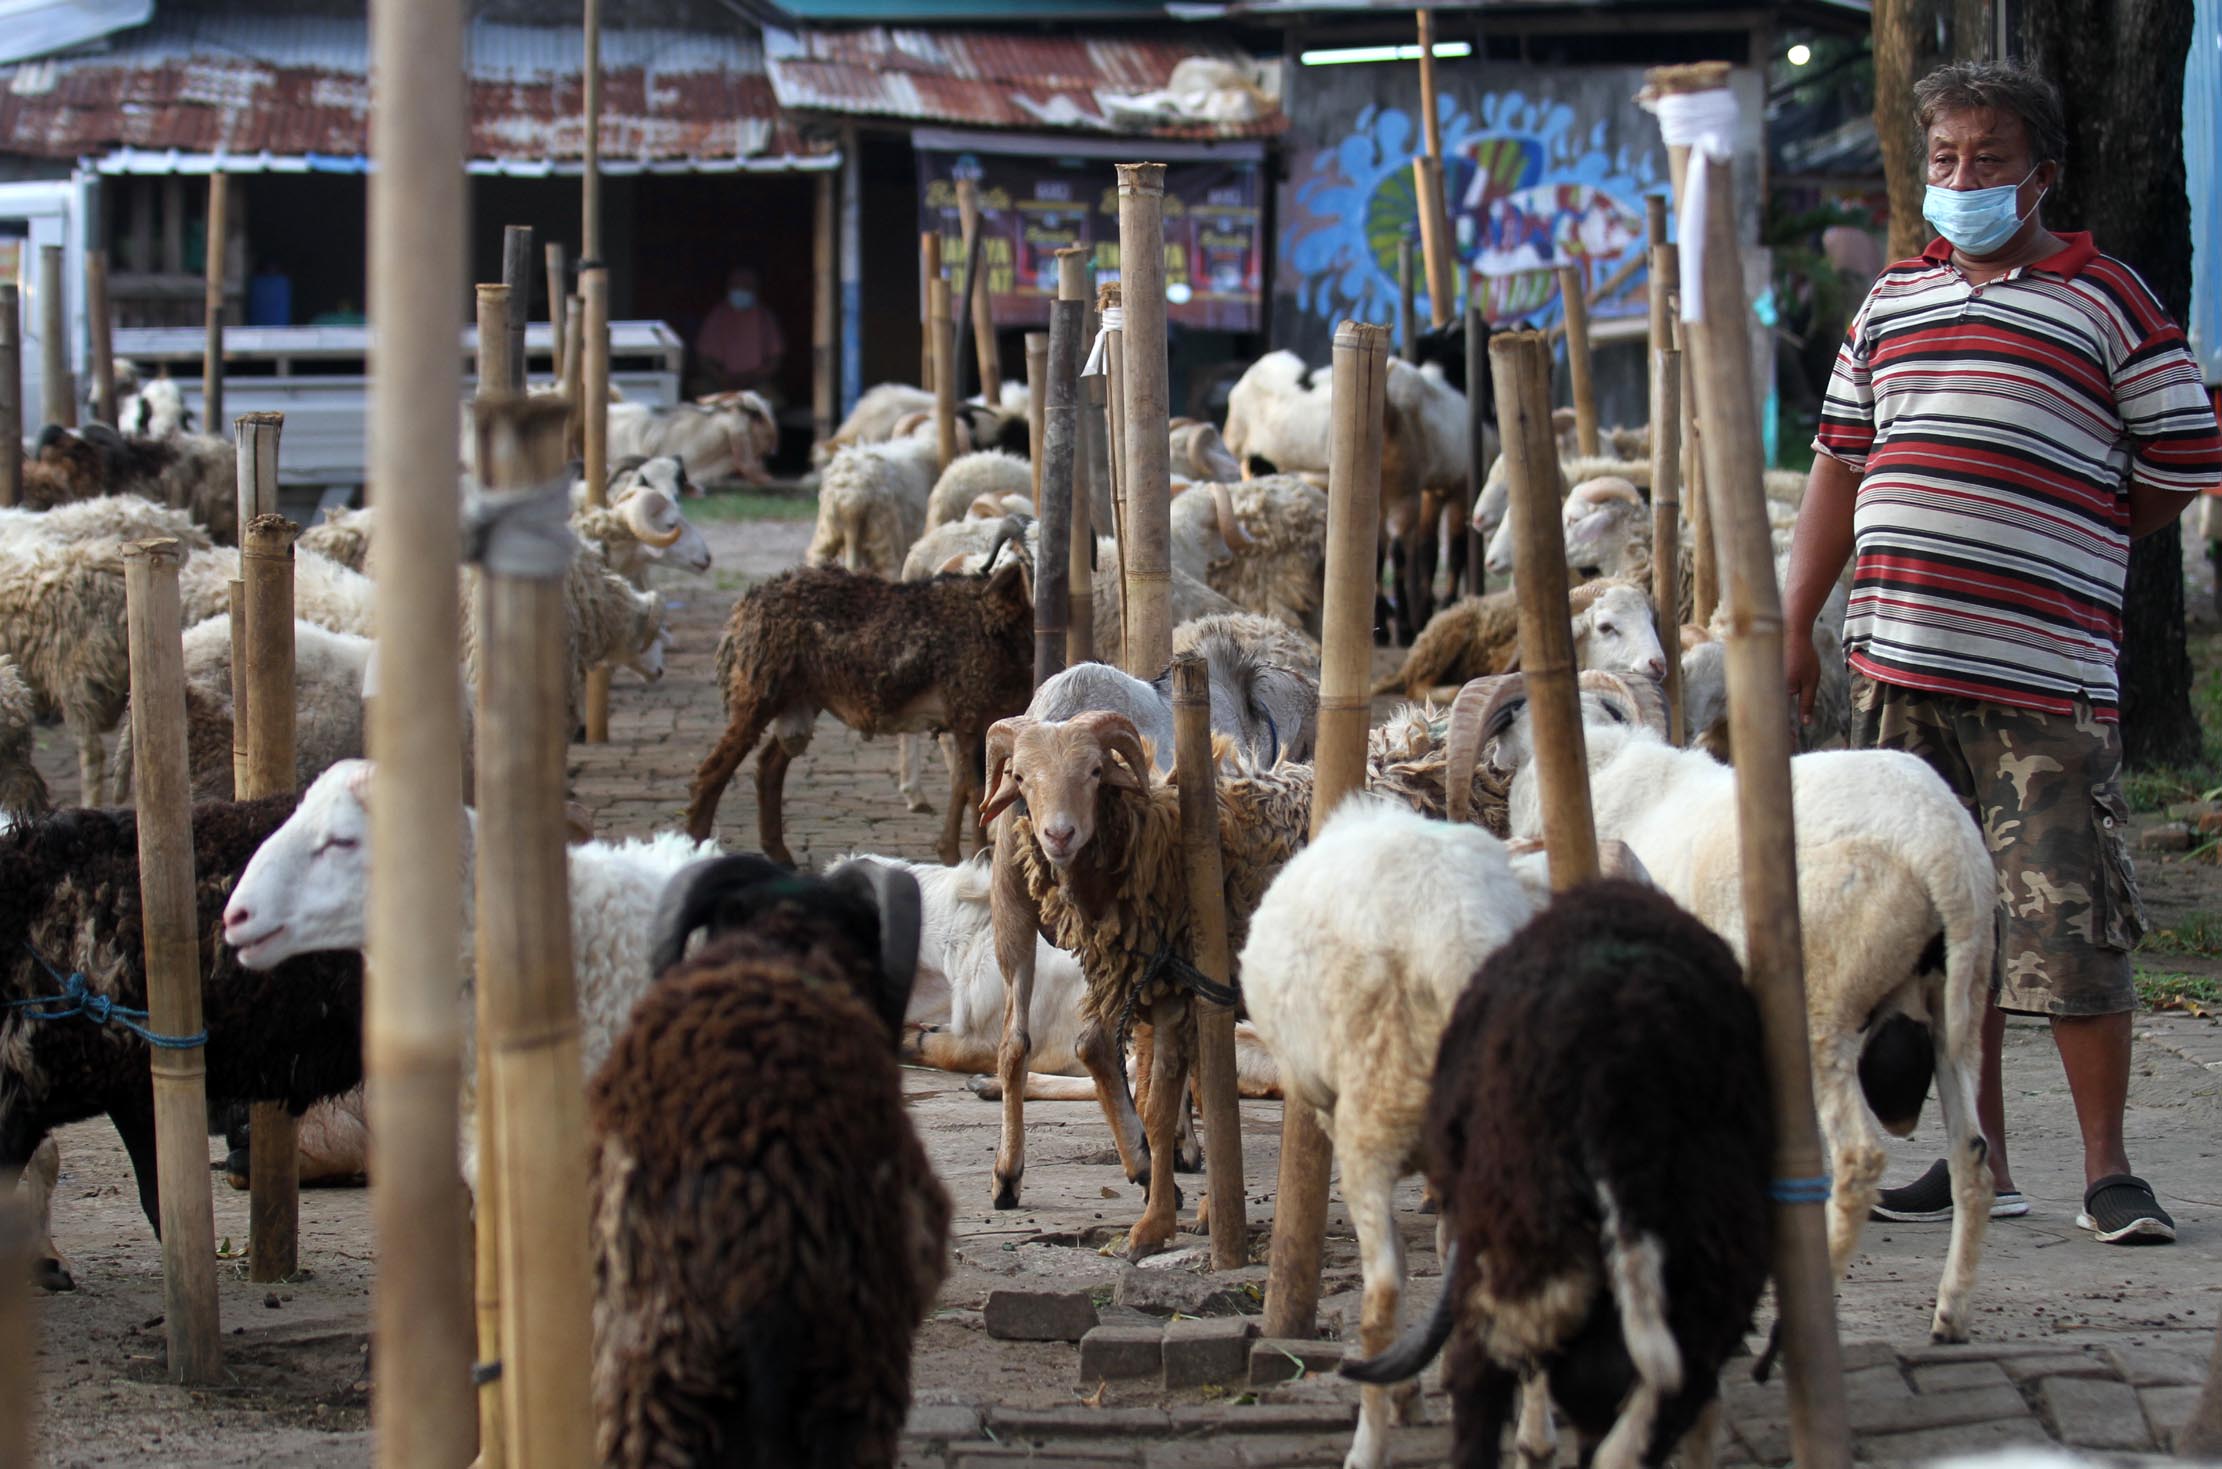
[0,353,1993,1469]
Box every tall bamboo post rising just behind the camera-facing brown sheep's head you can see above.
[1118,162,1173,678]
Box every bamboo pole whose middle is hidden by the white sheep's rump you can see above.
[1264,322,1389,1340]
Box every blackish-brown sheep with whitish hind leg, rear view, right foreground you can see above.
[1338,882,1773,1469]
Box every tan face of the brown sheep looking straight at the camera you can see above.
[980,711,1149,869]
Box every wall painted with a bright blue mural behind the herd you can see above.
[1273,62,1762,362]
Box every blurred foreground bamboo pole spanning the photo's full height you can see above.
[362,0,475,1440]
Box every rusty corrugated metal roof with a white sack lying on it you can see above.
[764,27,1287,138]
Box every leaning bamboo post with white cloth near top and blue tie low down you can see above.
[1682,145,1851,1469]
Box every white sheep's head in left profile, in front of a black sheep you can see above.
[224,760,371,969]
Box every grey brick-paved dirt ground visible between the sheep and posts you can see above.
[17,502,2222,1469]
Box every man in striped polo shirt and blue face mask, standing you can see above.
[1784,62,2222,1242]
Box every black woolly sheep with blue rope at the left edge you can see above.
[0,796,362,1289]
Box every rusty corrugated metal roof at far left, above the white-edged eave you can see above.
[0,16,833,171]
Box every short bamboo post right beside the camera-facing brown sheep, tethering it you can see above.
[1173,653,1249,1269]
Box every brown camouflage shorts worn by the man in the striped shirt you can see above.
[1851,673,2144,1016]
